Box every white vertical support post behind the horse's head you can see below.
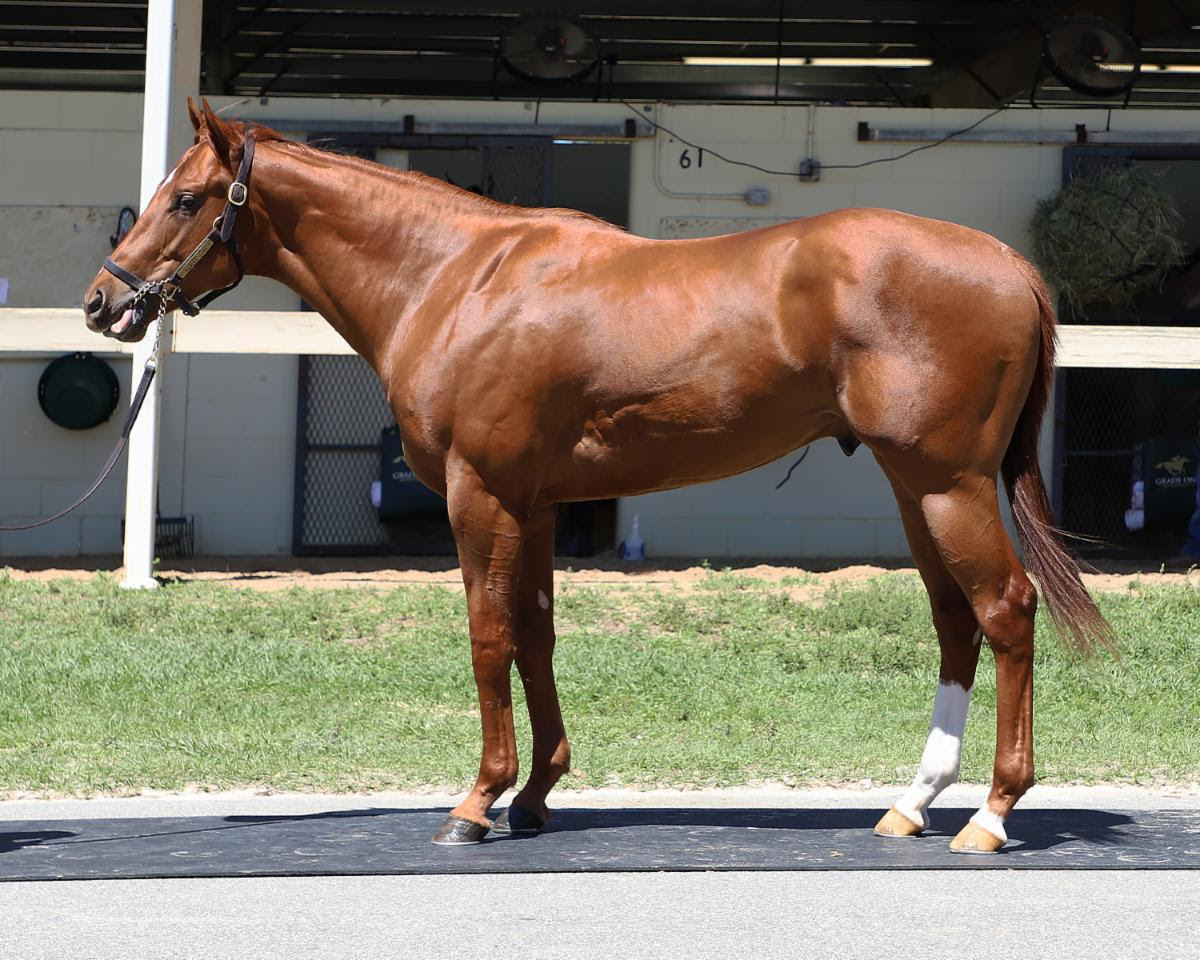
[121,0,202,588]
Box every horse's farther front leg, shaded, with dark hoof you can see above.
[492,508,571,833]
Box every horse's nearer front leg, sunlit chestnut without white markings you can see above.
[433,467,524,844]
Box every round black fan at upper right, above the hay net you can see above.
[1042,17,1141,97]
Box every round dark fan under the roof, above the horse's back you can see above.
[499,10,600,83]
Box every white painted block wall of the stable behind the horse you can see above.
[0,91,1196,557]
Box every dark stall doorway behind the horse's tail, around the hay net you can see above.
[1054,148,1200,558]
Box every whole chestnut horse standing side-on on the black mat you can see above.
[84,102,1111,852]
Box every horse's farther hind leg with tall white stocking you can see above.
[875,480,979,836]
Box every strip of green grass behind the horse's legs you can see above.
[0,574,1200,794]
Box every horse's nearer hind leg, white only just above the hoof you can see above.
[900,473,1037,853]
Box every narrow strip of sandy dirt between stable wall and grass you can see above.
[2,557,1200,595]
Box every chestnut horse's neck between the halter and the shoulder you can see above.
[244,142,468,372]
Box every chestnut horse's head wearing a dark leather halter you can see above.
[83,97,253,342]
